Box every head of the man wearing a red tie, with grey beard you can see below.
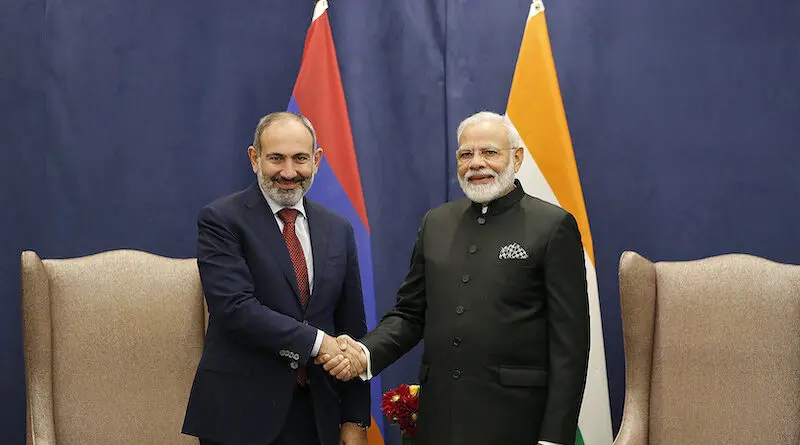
[247,116,322,207]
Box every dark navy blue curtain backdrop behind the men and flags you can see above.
[0,0,800,444]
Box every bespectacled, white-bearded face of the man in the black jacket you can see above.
[456,120,523,204]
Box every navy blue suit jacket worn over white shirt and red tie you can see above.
[183,183,370,445]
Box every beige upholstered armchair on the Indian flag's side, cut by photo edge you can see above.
[614,252,800,445]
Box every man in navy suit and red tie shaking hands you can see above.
[183,112,370,445]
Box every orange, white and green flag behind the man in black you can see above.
[506,0,612,445]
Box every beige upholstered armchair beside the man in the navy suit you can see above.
[22,250,207,445]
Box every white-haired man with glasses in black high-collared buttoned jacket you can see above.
[318,112,589,445]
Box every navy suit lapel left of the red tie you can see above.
[245,182,302,302]
